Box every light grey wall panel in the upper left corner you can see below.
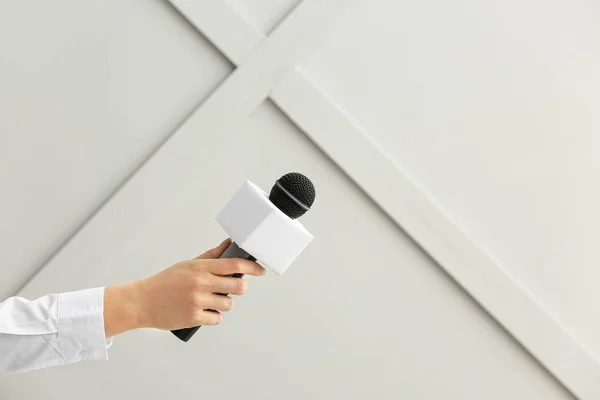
[0,0,232,297]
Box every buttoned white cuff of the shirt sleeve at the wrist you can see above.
[58,287,112,364]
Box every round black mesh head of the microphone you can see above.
[269,172,315,219]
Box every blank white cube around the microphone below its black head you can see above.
[216,181,313,275]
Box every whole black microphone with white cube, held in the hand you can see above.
[171,172,316,342]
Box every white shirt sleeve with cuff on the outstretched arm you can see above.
[0,288,112,372]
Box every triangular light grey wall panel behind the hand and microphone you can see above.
[0,104,570,400]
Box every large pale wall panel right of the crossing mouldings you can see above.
[302,0,600,359]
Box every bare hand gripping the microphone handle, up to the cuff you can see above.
[104,240,265,337]
